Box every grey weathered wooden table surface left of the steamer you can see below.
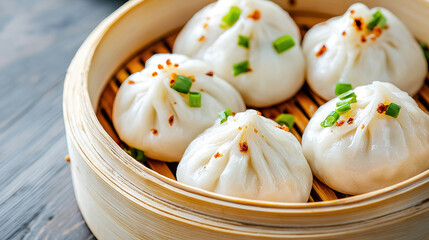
[0,0,124,239]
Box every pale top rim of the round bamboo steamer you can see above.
[63,0,429,212]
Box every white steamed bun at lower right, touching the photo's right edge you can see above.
[302,81,429,195]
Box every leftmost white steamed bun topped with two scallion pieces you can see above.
[113,54,245,162]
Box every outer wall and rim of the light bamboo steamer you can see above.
[64,0,429,239]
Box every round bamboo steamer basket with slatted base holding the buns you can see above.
[63,0,429,239]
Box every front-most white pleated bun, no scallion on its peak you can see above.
[177,110,313,202]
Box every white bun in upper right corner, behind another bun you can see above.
[303,3,427,99]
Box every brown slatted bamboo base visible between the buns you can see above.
[96,12,429,202]
